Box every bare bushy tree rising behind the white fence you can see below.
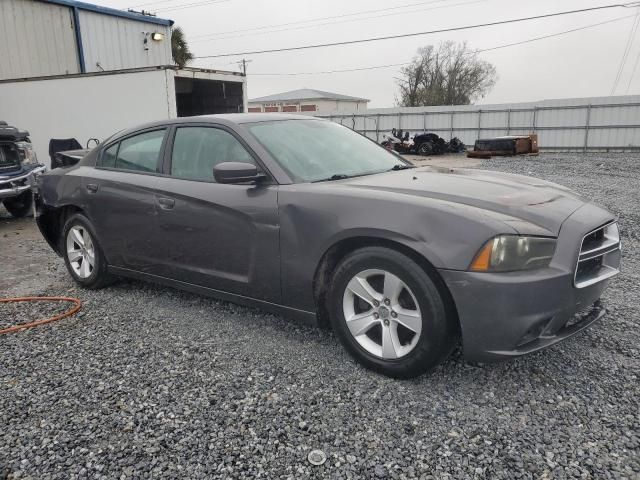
[397,41,497,107]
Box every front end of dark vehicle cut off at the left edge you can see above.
[0,121,45,218]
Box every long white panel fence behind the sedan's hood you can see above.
[317,95,640,151]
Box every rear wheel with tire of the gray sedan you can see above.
[60,213,115,289]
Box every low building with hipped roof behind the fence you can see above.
[249,88,369,114]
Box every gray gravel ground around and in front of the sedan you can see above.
[0,154,640,479]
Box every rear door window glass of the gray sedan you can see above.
[115,129,166,172]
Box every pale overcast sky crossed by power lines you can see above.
[102,0,640,108]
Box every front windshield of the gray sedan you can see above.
[248,120,409,182]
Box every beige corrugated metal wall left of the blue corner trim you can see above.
[0,0,80,80]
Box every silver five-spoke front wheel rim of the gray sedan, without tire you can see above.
[342,269,422,360]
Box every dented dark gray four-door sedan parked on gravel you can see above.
[37,114,620,377]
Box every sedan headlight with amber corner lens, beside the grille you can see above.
[470,235,556,272]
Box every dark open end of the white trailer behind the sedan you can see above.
[175,77,244,117]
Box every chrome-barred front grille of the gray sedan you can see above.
[574,222,620,288]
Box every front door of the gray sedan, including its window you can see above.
[156,124,280,302]
